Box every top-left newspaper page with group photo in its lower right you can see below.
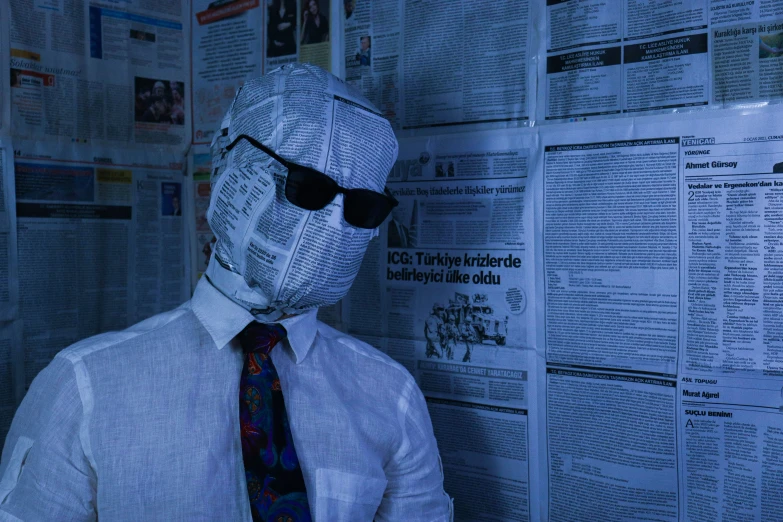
[9,0,191,151]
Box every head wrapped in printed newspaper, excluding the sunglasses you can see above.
[206,64,398,321]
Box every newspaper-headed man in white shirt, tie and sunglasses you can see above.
[0,64,452,522]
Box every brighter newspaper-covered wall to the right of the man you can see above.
[340,0,783,522]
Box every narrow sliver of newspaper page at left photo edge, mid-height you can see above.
[0,136,19,321]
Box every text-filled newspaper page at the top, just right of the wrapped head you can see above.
[344,0,540,134]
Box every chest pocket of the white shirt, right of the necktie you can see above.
[315,468,386,522]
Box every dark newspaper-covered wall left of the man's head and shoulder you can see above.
[0,0,192,443]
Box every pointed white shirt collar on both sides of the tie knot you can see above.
[190,277,318,364]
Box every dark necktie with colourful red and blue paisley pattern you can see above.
[239,322,311,522]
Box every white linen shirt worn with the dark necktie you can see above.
[0,279,453,522]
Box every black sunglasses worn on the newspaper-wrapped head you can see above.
[226,134,399,228]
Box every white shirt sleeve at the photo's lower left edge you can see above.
[0,356,97,522]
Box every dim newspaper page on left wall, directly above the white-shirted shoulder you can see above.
[15,141,189,387]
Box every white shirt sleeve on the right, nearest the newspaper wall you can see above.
[375,379,454,522]
